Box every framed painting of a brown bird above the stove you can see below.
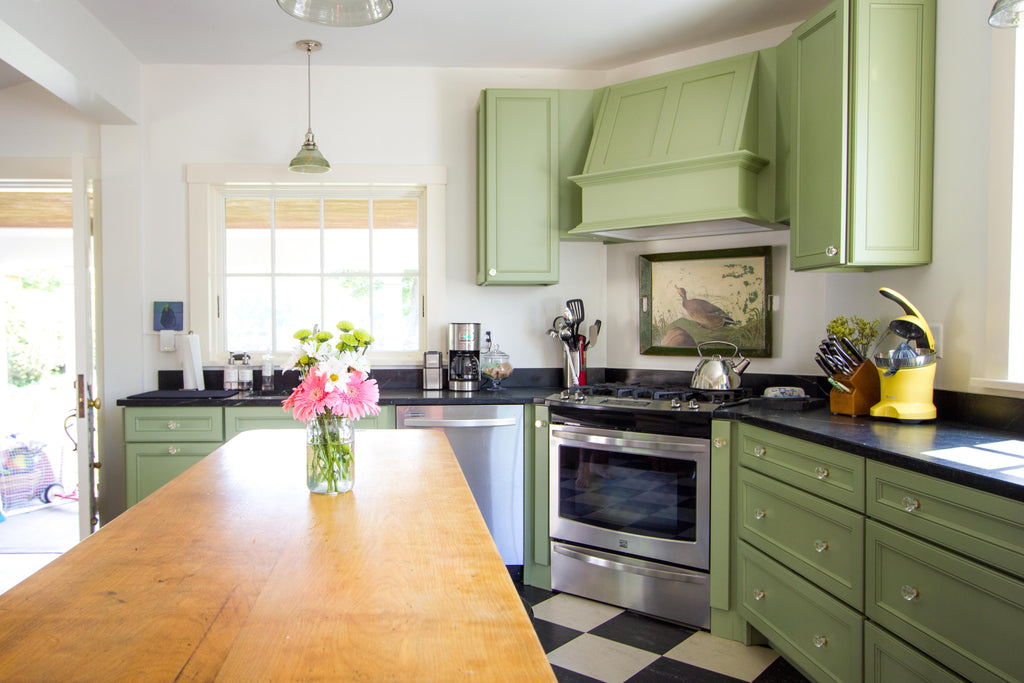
[640,247,771,357]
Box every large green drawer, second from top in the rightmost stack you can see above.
[864,520,1024,682]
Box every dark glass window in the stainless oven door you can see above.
[557,443,697,542]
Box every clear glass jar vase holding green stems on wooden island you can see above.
[306,413,355,496]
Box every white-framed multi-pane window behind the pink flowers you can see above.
[188,167,443,365]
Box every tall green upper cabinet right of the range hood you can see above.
[786,0,935,270]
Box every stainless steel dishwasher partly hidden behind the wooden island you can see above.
[395,405,523,566]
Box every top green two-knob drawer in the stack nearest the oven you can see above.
[739,424,864,512]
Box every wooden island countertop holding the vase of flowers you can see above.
[0,430,555,682]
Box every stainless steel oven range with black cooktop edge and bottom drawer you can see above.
[546,389,714,628]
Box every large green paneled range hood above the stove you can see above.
[569,50,785,241]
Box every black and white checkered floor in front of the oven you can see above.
[517,584,807,683]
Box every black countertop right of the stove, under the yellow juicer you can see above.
[715,404,1024,502]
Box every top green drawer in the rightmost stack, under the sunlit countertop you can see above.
[867,462,1024,577]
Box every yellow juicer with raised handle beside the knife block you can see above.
[870,287,936,422]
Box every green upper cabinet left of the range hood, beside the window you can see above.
[476,88,593,285]
